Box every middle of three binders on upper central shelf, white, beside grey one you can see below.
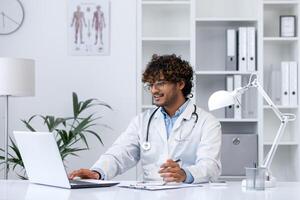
[238,27,247,72]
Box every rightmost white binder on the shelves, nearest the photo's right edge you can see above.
[289,62,298,106]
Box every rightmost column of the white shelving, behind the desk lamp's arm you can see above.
[262,0,300,181]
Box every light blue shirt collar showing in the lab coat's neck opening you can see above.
[161,99,190,138]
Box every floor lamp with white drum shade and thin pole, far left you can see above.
[0,57,35,179]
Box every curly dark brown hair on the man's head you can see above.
[142,54,193,98]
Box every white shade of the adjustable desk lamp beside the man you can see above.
[208,90,235,110]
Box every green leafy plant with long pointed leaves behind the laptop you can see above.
[0,92,112,179]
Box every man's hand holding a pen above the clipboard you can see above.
[158,159,186,182]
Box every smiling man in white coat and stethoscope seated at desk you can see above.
[69,54,221,183]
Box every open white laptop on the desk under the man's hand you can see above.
[14,131,118,189]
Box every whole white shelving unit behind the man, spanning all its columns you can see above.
[137,0,300,180]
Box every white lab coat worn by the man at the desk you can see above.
[91,101,221,183]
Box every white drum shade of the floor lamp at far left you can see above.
[0,58,35,96]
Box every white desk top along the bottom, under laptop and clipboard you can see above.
[0,180,300,200]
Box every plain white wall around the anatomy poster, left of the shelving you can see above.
[0,0,136,178]
